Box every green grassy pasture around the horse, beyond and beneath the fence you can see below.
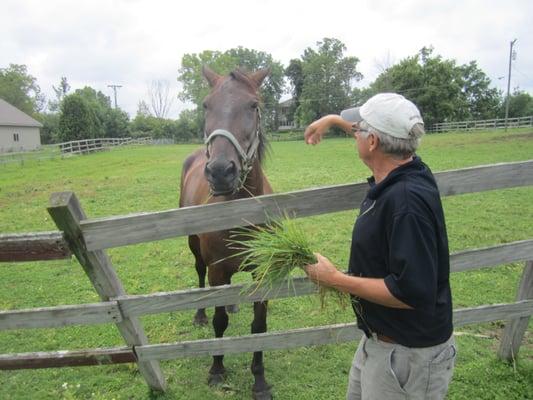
[0,129,533,400]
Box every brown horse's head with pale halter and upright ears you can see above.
[202,67,270,196]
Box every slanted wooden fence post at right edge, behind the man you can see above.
[498,261,533,361]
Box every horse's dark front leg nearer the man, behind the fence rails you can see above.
[252,301,272,400]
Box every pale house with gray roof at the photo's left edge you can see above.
[0,99,43,153]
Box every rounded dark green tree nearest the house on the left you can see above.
[59,93,104,142]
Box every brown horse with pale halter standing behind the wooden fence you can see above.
[180,67,272,400]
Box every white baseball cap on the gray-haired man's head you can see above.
[341,93,424,139]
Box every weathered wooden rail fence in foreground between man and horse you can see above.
[0,160,533,390]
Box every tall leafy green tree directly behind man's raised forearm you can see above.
[289,38,362,125]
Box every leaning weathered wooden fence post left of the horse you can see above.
[48,192,166,391]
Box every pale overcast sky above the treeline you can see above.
[0,0,533,117]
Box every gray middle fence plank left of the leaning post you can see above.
[0,302,122,330]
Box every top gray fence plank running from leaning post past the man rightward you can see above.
[81,160,533,250]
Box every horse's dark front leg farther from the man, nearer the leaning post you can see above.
[208,266,230,385]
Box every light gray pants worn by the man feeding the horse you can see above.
[346,335,456,400]
